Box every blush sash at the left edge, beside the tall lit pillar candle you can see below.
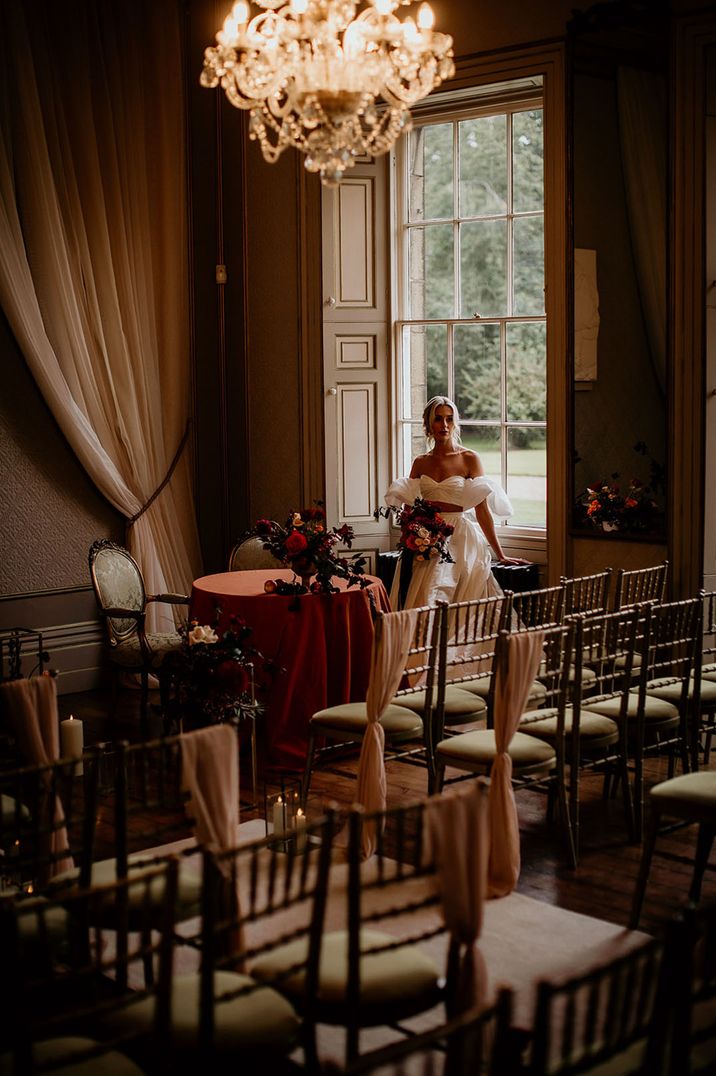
[0,676,74,875]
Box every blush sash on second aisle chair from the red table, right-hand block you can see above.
[488,632,545,897]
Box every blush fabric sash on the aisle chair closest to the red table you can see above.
[355,609,418,859]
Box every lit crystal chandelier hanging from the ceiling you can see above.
[200,0,454,186]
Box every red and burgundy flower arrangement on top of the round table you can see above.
[251,505,368,594]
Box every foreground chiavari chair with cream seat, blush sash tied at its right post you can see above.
[252,788,487,1065]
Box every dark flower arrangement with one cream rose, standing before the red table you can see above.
[164,609,276,731]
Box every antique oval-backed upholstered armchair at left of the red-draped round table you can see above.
[89,538,189,738]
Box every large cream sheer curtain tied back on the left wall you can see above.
[0,0,199,629]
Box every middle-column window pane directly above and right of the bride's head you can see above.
[453,324,502,420]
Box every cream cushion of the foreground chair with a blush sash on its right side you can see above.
[251,930,440,1015]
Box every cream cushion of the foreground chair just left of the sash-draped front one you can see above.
[103,972,300,1054]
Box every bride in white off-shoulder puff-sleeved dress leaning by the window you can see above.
[385,396,527,609]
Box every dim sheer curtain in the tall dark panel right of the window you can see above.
[617,67,666,392]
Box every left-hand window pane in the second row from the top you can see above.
[408,224,454,317]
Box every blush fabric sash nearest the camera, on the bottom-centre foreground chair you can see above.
[425,781,490,1017]
